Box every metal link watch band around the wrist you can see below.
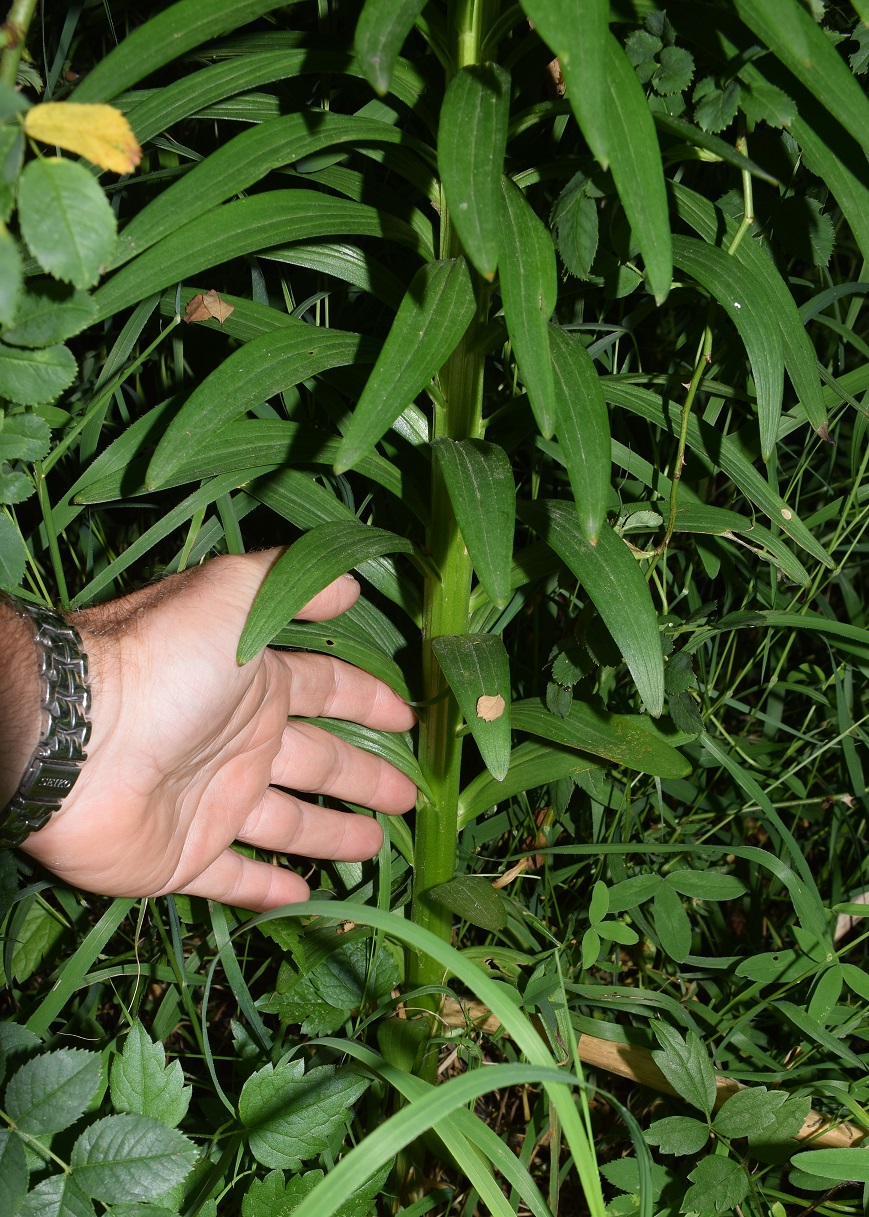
[0,593,90,847]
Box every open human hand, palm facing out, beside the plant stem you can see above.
[22,550,416,912]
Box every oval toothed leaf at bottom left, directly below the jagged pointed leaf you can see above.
[69,1115,198,1204]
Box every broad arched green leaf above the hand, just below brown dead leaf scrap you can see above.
[147,321,370,487]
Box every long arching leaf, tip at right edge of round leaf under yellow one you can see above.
[108,111,404,270]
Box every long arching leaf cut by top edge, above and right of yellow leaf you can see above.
[75,0,296,101]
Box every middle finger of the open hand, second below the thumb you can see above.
[270,723,416,817]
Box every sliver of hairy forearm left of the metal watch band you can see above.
[0,596,41,811]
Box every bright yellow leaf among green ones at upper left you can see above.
[23,101,142,173]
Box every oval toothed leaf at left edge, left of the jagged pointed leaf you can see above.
[4,1048,101,1137]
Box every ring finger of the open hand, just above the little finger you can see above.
[233,787,383,862]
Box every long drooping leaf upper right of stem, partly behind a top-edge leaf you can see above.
[606,34,673,304]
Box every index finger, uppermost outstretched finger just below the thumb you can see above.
[269,651,416,731]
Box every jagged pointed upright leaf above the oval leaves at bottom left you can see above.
[111,1019,192,1128]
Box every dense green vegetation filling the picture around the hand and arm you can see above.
[0,0,869,1217]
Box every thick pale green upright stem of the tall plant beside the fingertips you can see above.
[408,0,497,1061]
